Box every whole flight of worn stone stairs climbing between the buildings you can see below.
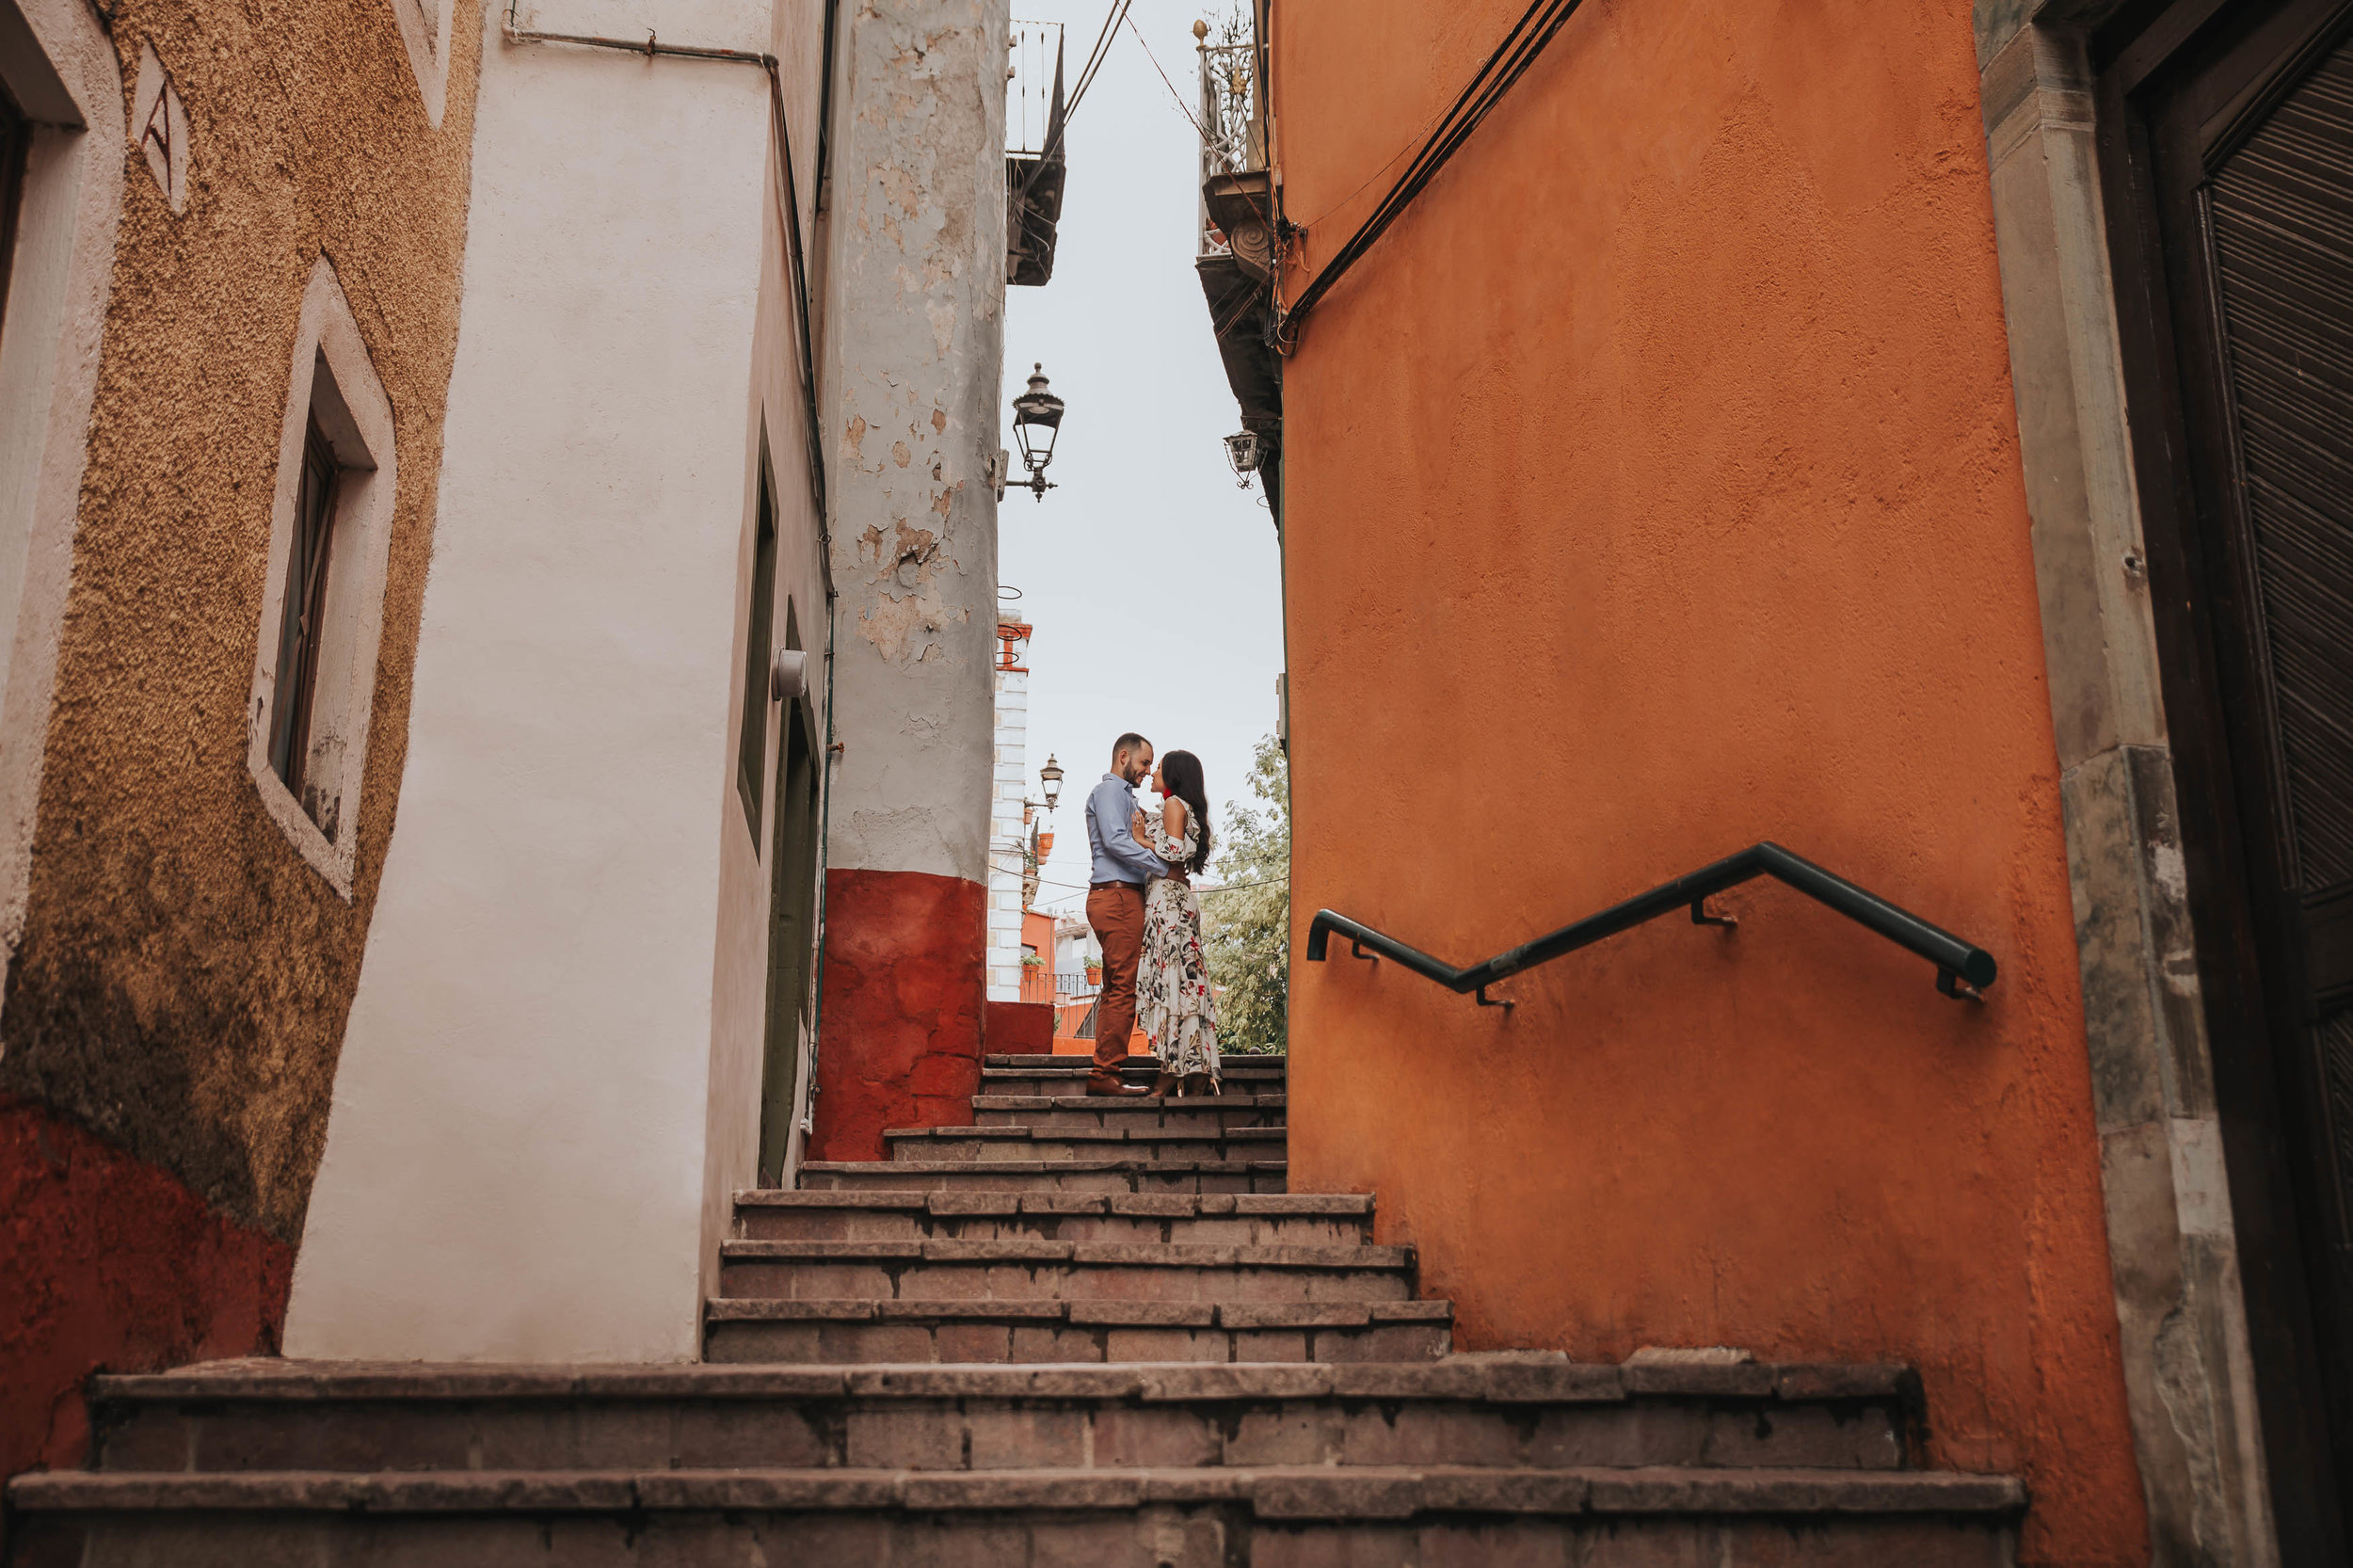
[8,1057,2024,1568]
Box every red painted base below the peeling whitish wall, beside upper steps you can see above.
[808,872,988,1160]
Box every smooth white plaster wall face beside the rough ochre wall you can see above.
[285,3,775,1361]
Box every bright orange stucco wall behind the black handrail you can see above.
[1271,0,2146,1563]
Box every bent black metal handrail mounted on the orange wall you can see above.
[1308,843,1995,1008]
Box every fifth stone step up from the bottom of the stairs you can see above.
[737,1189,1372,1245]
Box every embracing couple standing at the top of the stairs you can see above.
[1087,734,1217,1097]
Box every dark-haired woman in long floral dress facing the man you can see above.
[1134,751,1217,1097]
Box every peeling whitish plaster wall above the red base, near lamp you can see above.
[824,0,1010,883]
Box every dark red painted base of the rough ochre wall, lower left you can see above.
[0,1095,295,1476]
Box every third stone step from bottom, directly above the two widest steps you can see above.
[704,1297,1454,1366]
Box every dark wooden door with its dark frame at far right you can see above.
[2104,0,2353,1534]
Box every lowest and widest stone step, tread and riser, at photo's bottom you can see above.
[9,1466,2026,1568]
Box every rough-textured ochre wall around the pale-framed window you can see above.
[0,0,480,1240]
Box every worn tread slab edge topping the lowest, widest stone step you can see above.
[8,1464,2026,1521]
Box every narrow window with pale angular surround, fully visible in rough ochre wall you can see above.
[248,257,395,897]
